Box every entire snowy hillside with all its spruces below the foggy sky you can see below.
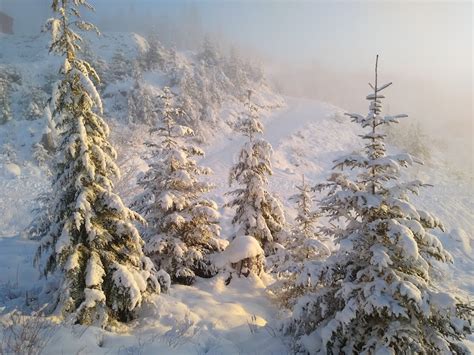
[0,0,474,355]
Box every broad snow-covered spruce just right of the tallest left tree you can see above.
[131,88,223,285]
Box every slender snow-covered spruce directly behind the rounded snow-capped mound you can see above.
[226,92,285,255]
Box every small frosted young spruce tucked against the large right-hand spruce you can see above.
[270,175,331,307]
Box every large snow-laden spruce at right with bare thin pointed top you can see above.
[286,57,473,354]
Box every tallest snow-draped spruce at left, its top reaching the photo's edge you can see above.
[32,0,160,326]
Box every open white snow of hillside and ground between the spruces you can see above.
[0,29,474,354]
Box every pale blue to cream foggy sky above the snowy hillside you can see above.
[0,0,474,171]
